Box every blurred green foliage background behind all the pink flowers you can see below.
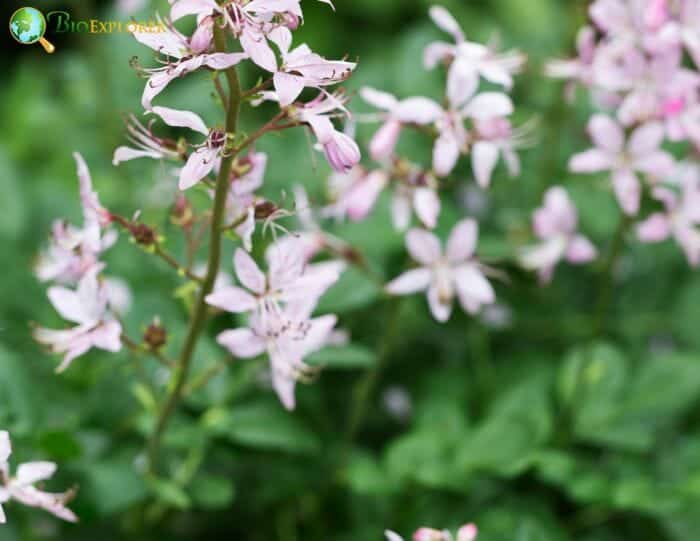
[0,0,700,541]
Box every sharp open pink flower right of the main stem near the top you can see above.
[269,26,357,107]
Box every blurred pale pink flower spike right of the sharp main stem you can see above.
[324,6,527,322]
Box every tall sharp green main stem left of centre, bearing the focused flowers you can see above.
[148,24,241,473]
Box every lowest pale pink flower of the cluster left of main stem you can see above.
[34,265,121,373]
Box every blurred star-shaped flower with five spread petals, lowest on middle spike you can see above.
[386,219,496,323]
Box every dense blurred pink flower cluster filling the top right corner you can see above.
[546,0,700,265]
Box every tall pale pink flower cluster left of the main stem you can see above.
[34,153,125,372]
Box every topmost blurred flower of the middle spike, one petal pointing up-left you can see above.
[424,6,525,88]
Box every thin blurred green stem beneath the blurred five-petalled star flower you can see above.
[346,297,401,446]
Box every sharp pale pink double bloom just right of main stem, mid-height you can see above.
[207,242,344,409]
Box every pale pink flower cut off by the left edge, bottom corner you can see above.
[0,430,78,524]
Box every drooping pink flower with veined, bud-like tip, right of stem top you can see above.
[293,90,361,173]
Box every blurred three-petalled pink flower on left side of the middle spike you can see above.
[360,87,443,161]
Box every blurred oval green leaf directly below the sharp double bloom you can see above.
[203,402,321,454]
